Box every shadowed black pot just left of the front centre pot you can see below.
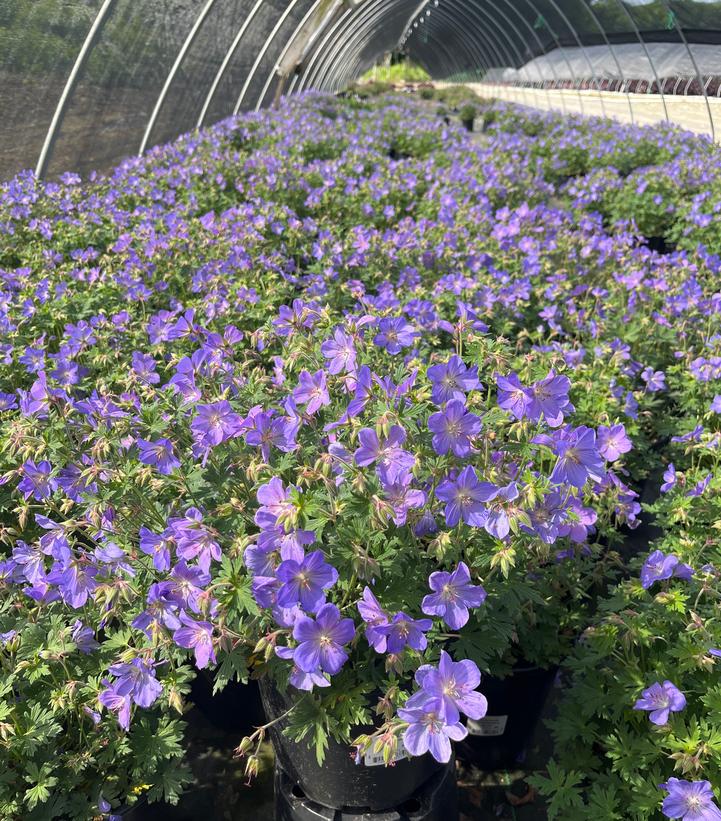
[190,670,265,735]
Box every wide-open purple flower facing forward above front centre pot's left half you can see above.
[293,604,355,676]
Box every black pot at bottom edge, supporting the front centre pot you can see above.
[275,761,458,821]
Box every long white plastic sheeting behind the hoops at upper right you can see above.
[496,43,721,83]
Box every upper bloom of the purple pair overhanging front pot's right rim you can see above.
[405,650,488,721]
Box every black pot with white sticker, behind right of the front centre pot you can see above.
[456,667,556,770]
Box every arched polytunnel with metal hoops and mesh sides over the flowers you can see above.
[0,0,721,178]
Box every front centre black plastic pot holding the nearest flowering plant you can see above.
[260,679,444,817]
